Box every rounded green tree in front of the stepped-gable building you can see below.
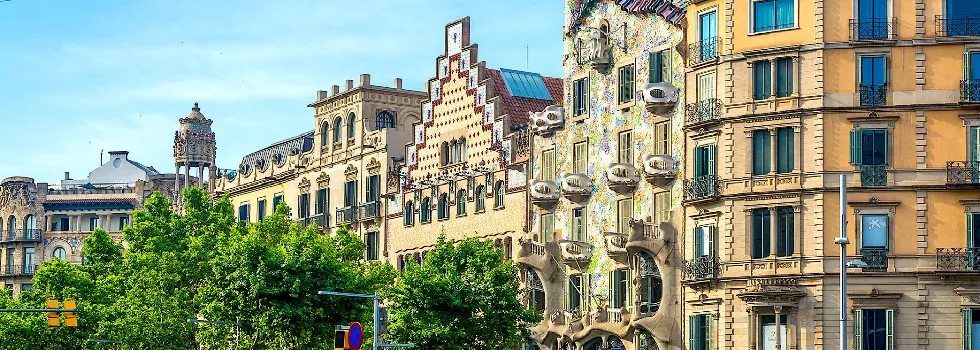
[384,236,541,350]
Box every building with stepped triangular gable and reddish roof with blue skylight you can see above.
[387,17,562,269]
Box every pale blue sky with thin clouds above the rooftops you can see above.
[0,0,564,182]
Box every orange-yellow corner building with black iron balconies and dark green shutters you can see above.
[682,0,980,350]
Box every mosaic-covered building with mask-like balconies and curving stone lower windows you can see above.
[518,1,684,350]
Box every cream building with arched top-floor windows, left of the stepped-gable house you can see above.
[214,74,425,260]
